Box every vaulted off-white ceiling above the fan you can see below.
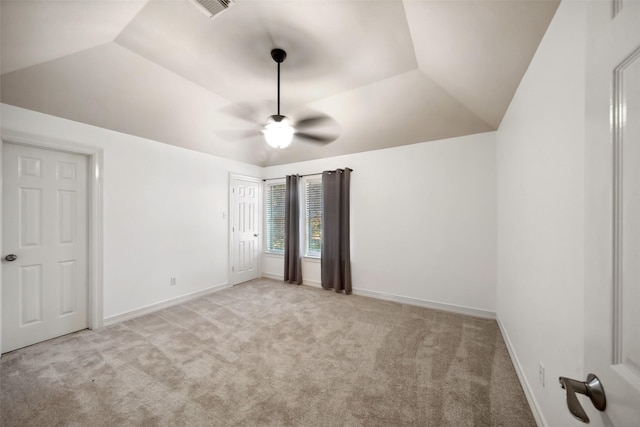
[0,0,558,166]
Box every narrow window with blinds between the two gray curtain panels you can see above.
[303,177,322,257]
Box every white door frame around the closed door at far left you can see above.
[0,129,104,354]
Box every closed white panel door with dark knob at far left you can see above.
[2,144,88,352]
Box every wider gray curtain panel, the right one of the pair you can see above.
[321,169,351,295]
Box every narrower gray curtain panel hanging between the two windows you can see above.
[284,175,302,285]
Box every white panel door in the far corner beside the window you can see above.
[231,178,260,285]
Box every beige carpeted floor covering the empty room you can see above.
[0,280,535,427]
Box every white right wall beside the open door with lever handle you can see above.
[497,1,586,426]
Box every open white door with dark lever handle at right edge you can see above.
[580,1,640,427]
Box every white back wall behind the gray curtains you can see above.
[263,132,496,313]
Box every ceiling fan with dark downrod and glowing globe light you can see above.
[221,48,338,149]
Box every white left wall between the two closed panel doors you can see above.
[1,104,262,318]
